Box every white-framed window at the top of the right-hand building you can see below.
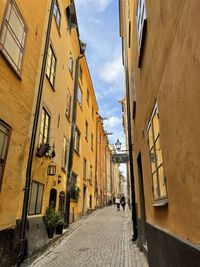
[136,0,147,51]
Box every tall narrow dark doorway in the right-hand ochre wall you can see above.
[137,153,147,253]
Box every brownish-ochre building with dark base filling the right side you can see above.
[119,0,200,267]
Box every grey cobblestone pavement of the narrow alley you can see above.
[28,206,148,267]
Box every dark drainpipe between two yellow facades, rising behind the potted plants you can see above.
[64,55,83,227]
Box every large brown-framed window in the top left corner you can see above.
[0,0,27,74]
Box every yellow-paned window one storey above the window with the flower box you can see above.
[46,45,56,86]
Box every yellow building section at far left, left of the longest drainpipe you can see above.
[0,0,48,266]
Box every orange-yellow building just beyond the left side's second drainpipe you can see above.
[70,57,98,221]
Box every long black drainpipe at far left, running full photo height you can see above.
[17,0,54,266]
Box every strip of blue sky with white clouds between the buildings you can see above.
[75,0,124,147]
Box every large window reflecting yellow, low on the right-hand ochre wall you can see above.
[147,104,167,200]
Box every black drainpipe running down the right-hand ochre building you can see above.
[125,62,138,242]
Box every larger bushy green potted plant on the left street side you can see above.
[45,205,59,238]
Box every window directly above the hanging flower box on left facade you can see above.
[39,108,50,144]
